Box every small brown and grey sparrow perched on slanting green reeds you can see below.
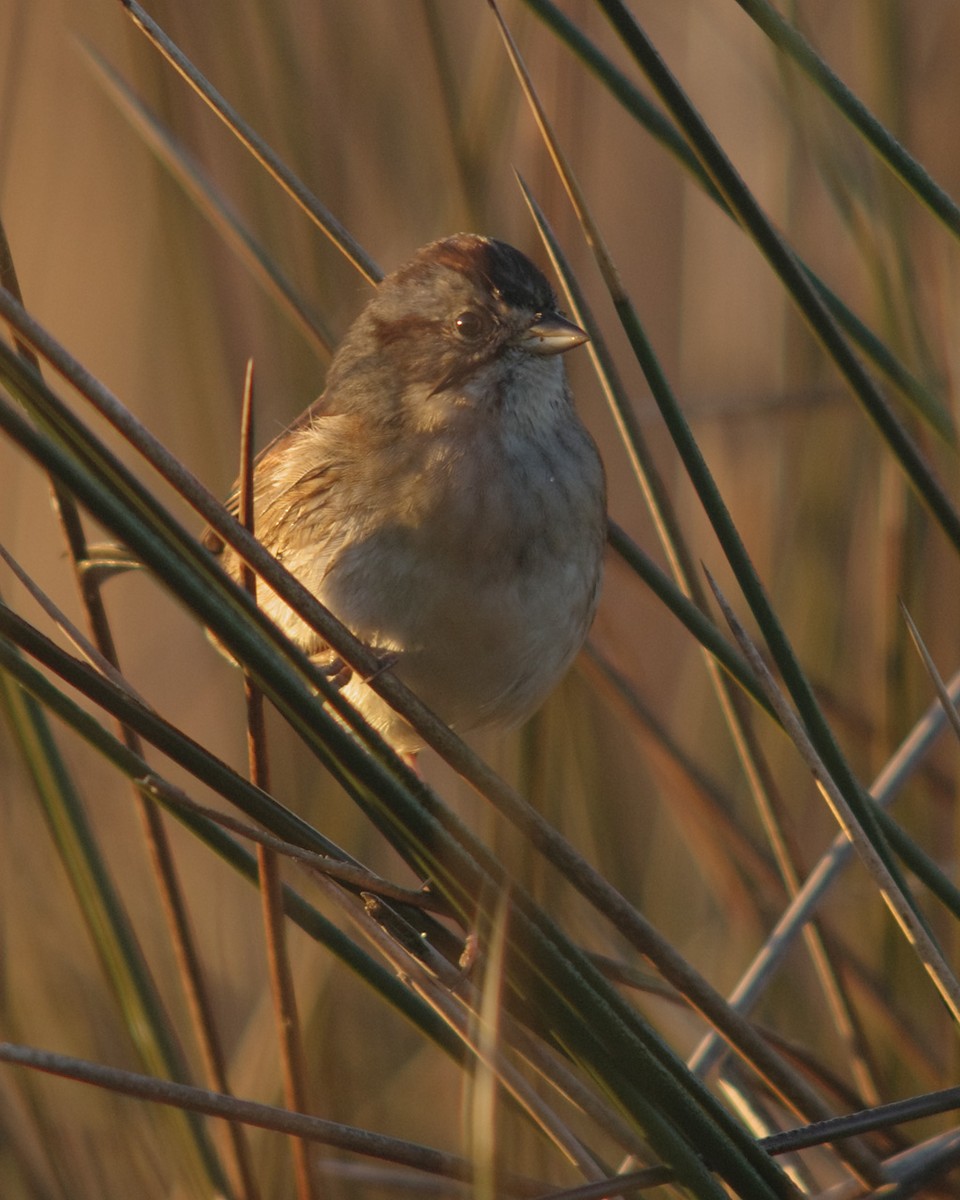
[204,234,606,754]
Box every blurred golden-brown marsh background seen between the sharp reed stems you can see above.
[0,0,960,1196]
